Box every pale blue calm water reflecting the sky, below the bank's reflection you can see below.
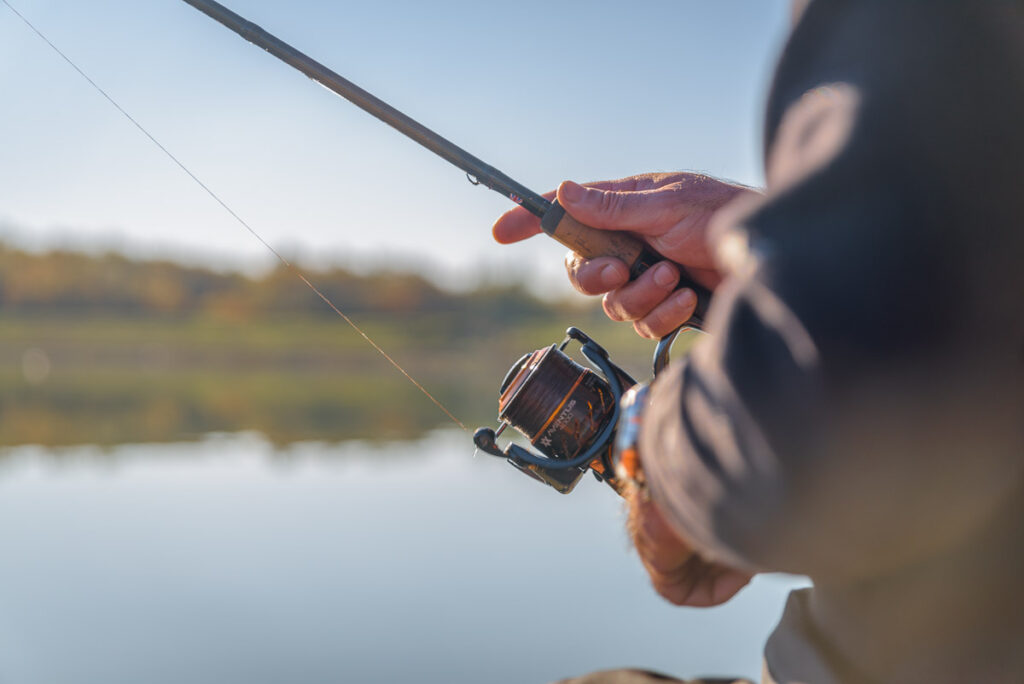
[0,432,798,684]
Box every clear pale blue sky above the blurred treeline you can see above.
[0,0,788,291]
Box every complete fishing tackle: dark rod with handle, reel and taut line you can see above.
[0,0,711,494]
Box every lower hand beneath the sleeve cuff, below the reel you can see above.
[628,494,753,608]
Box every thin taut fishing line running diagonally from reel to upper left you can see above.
[0,0,469,432]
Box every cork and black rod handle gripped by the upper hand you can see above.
[541,200,711,330]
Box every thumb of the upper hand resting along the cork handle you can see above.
[558,180,679,236]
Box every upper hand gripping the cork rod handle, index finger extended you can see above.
[493,172,754,339]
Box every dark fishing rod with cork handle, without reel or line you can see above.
[183,0,711,330]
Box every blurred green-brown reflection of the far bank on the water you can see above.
[0,372,479,446]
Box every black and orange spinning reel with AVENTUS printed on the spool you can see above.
[473,327,682,494]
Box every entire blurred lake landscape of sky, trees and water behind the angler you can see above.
[0,0,800,683]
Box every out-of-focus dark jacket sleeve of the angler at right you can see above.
[640,3,1024,580]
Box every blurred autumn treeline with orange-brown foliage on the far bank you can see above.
[0,245,556,320]
